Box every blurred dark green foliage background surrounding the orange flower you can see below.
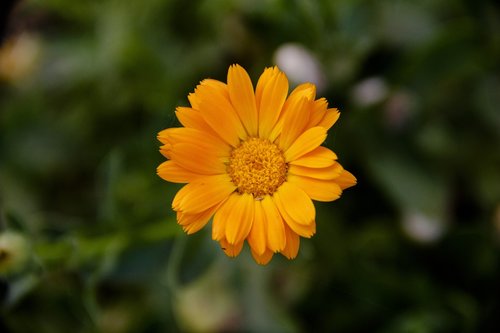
[0,0,500,333]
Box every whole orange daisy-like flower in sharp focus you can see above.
[157,65,356,265]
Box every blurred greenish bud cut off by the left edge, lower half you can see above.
[0,231,30,275]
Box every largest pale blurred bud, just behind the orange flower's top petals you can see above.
[274,43,325,91]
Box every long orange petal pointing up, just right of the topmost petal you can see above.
[257,71,288,138]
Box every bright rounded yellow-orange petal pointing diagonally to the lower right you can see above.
[274,182,316,225]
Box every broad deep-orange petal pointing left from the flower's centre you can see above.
[170,143,226,175]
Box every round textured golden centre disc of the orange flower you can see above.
[227,138,288,198]
